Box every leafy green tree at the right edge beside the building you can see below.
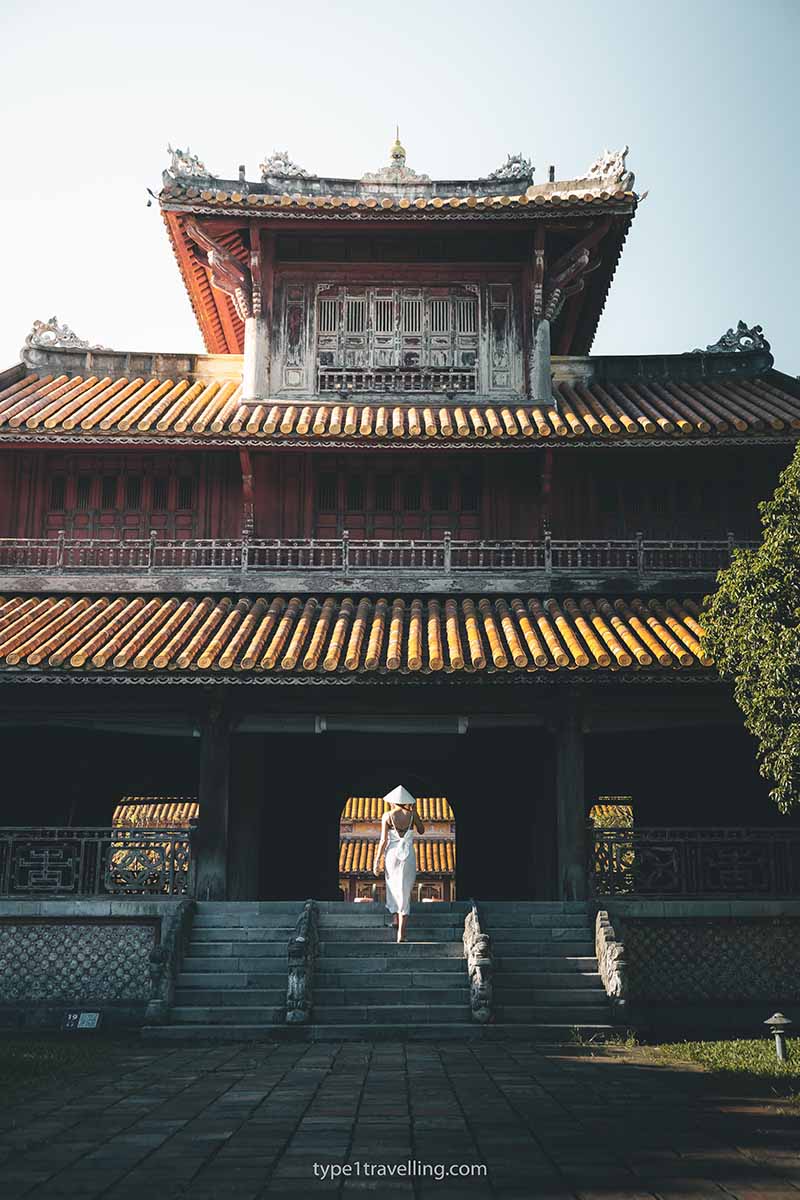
[703,445,800,812]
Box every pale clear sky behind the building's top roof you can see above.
[0,0,800,374]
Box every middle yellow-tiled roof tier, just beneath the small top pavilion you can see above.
[0,344,800,449]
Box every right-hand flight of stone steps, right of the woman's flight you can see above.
[479,900,613,1039]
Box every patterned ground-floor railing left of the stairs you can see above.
[0,826,194,898]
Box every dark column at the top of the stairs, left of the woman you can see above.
[194,701,230,900]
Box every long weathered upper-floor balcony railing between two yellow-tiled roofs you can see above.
[0,533,754,577]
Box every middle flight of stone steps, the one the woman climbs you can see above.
[312,901,480,1039]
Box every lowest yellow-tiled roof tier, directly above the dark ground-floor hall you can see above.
[0,595,711,682]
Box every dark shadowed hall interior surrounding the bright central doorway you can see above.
[253,730,555,900]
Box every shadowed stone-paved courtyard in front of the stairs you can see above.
[0,1042,800,1200]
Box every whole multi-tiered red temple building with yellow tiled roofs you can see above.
[0,139,800,900]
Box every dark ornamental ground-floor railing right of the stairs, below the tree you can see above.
[588,827,800,898]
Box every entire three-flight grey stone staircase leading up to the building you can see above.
[143,900,614,1042]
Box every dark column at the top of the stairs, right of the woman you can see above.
[555,695,587,900]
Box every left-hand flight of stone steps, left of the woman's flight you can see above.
[143,900,302,1040]
